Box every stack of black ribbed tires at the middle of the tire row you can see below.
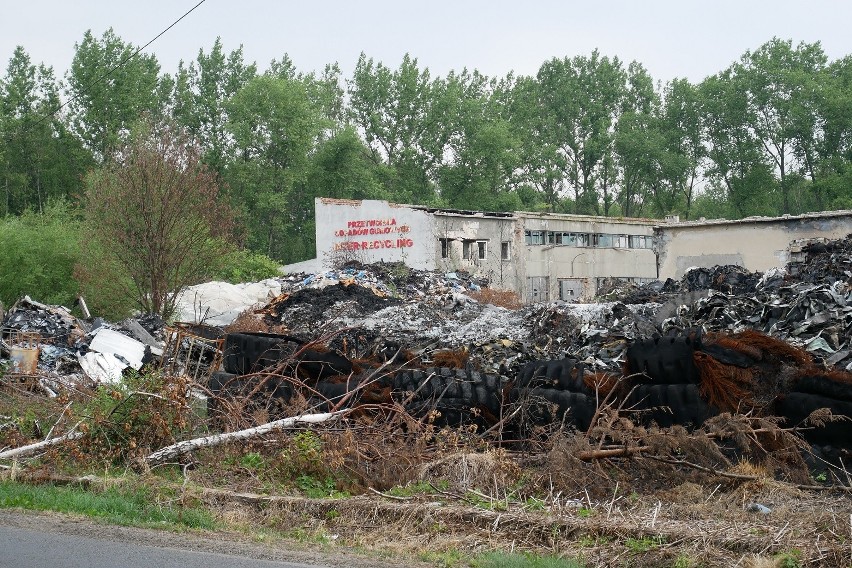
[392,367,503,428]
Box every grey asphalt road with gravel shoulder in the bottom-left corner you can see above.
[0,509,423,568]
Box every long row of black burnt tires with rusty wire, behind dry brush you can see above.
[208,330,852,464]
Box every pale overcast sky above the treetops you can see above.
[0,0,852,82]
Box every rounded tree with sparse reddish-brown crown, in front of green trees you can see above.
[77,121,233,318]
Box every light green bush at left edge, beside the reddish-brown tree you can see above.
[0,201,84,306]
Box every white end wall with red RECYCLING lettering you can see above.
[315,198,435,270]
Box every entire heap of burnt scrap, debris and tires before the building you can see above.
[3,238,852,466]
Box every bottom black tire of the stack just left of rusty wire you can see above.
[625,384,719,428]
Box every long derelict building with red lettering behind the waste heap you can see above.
[285,198,852,303]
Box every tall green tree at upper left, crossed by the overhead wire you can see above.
[66,28,162,161]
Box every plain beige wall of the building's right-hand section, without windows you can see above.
[656,211,852,279]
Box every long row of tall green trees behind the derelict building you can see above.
[0,30,852,262]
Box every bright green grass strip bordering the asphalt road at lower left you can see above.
[0,481,215,529]
